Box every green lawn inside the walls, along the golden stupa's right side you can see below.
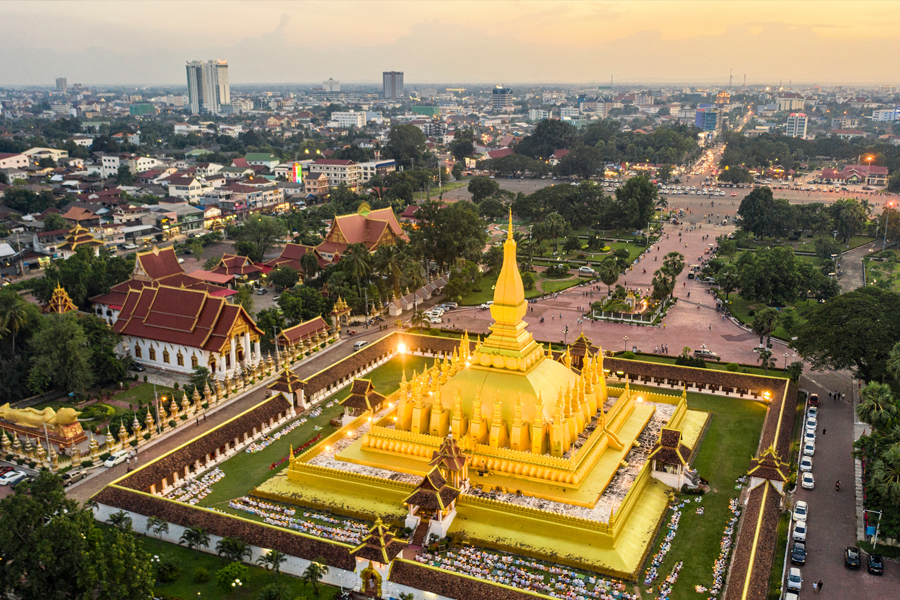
[633,386,766,600]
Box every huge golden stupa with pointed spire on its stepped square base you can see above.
[253,214,707,578]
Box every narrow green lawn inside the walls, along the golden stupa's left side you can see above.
[198,355,434,508]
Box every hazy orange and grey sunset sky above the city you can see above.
[0,0,900,86]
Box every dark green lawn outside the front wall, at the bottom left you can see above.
[100,524,349,600]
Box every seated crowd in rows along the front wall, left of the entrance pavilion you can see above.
[228,496,369,544]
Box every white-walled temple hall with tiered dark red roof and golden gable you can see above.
[113,285,263,379]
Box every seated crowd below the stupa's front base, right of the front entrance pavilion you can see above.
[416,547,637,600]
